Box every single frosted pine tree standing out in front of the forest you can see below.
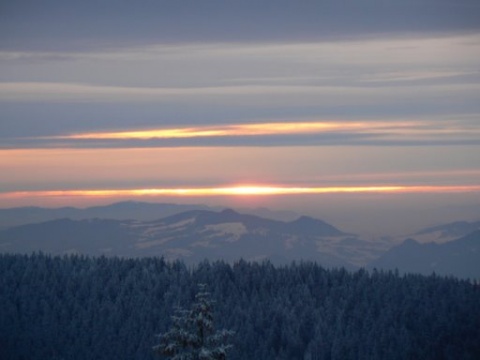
[153,284,233,360]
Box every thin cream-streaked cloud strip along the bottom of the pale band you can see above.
[0,82,480,106]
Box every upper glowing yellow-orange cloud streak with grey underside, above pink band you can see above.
[3,119,480,148]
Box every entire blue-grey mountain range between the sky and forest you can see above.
[0,202,480,279]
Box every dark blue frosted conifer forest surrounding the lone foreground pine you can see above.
[0,254,480,360]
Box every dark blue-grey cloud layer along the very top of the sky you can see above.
[0,0,480,50]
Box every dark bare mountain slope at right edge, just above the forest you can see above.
[369,230,480,279]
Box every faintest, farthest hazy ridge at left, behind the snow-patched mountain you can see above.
[0,201,298,229]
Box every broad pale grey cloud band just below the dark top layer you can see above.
[0,35,480,107]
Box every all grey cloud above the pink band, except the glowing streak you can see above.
[0,5,480,148]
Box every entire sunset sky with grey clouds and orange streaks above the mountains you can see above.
[0,0,480,233]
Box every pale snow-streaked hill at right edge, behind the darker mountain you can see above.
[414,221,480,242]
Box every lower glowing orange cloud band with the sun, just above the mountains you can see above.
[0,185,480,199]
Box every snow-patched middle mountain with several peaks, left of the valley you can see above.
[0,205,361,268]
